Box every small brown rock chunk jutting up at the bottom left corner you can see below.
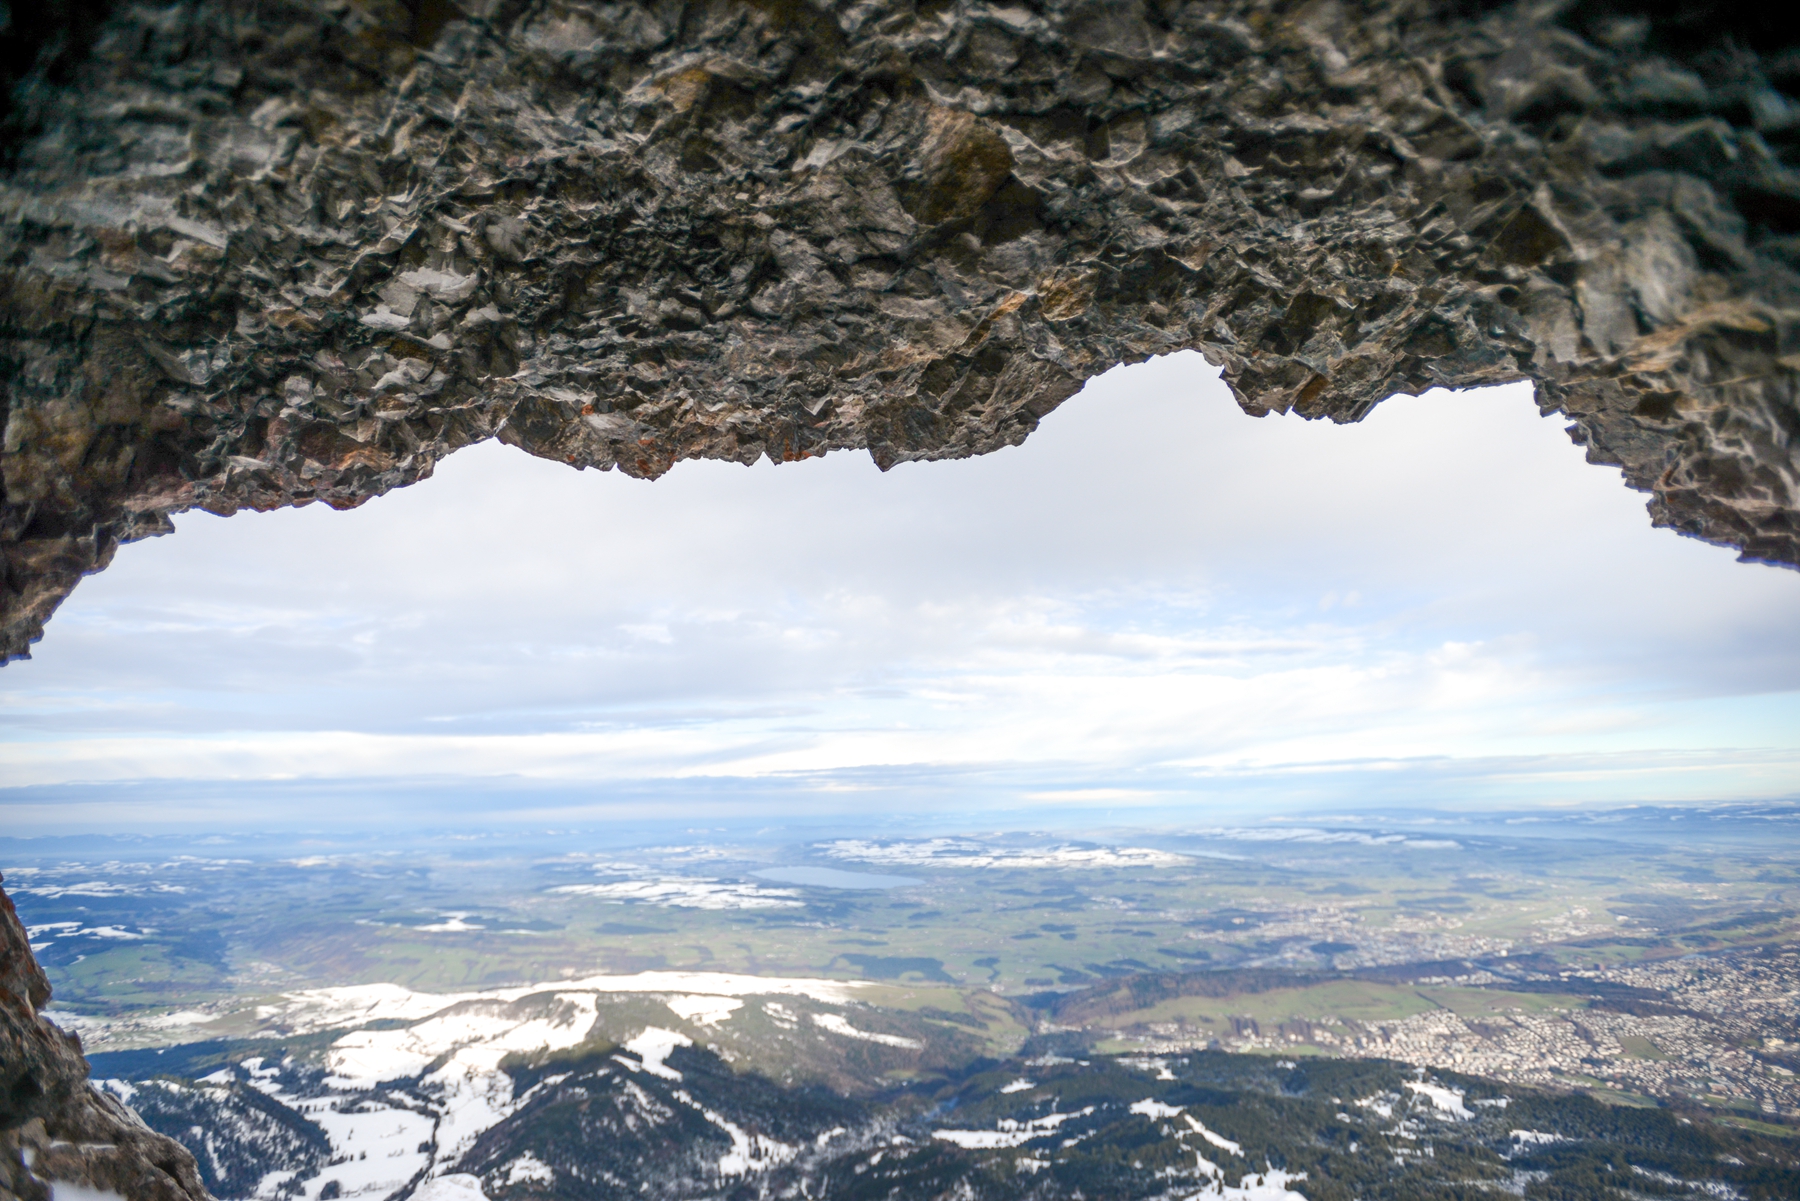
[0,878,209,1201]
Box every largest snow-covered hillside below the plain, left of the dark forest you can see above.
[99,972,974,1201]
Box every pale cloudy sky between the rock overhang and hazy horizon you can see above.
[0,353,1800,834]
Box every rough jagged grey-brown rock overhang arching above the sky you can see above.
[0,0,1800,655]
